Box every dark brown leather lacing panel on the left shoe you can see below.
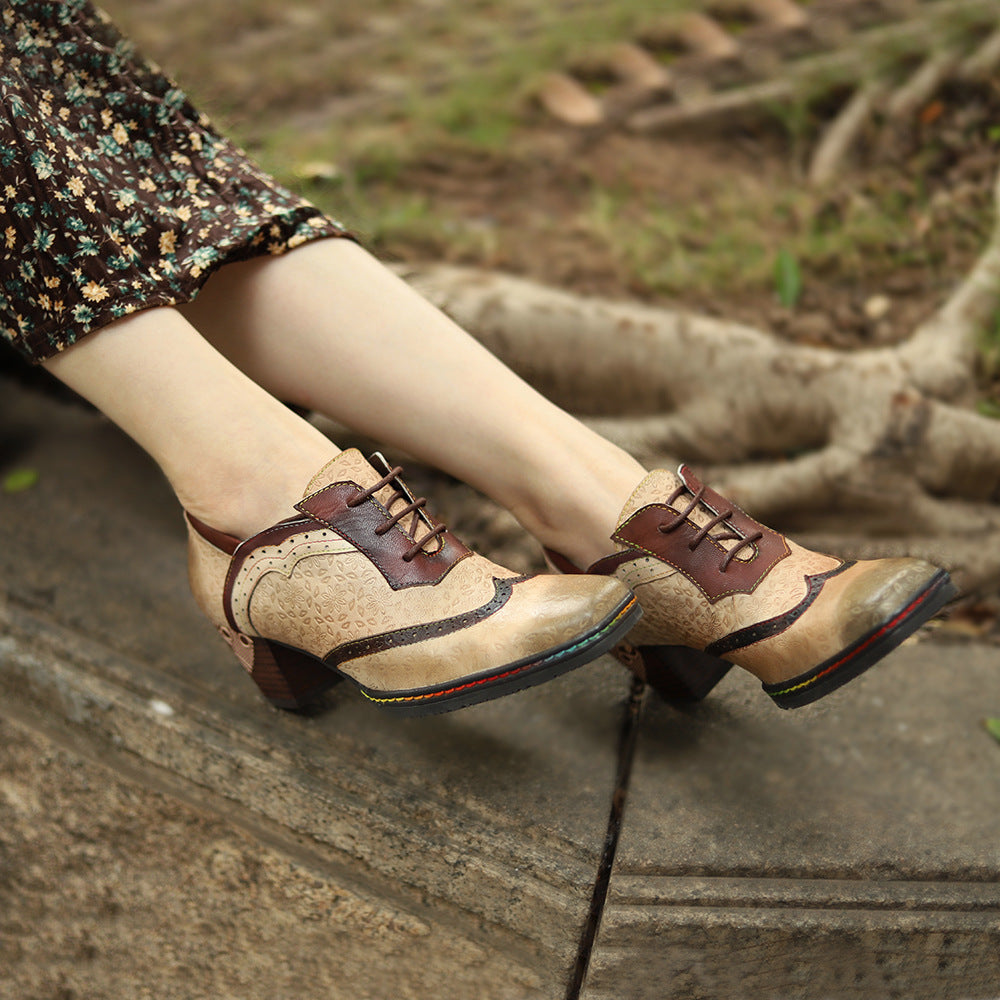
[295,483,472,590]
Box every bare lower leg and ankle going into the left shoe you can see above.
[45,309,337,538]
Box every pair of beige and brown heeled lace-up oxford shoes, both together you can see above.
[188,450,955,715]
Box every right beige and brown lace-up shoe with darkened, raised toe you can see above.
[548,466,957,708]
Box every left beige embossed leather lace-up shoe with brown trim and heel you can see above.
[188,450,642,715]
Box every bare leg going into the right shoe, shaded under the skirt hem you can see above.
[183,240,644,565]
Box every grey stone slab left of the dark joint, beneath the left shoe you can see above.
[0,385,628,995]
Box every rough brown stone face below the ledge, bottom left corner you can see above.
[0,701,541,1000]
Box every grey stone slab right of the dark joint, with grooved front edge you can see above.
[583,643,1000,1000]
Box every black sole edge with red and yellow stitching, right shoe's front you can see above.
[762,570,958,708]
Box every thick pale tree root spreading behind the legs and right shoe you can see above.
[394,169,1000,591]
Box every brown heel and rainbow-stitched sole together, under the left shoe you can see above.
[219,597,642,716]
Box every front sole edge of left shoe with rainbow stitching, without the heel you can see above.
[358,597,642,717]
